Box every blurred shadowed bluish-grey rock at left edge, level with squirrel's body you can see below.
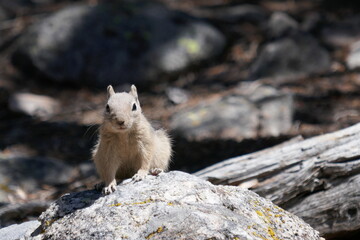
[0,157,73,197]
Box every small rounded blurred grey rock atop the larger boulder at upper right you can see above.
[267,12,299,38]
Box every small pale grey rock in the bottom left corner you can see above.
[0,220,40,240]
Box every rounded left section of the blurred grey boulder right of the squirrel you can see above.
[170,95,259,140]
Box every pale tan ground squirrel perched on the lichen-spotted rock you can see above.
[93,85,171,194]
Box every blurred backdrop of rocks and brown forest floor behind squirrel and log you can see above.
[0,0,360,232]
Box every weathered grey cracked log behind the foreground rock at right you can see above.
[195,124,360,237]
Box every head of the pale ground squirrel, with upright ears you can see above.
[104,85,141,132]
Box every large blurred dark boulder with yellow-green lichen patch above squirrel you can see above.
[13,1,225,87]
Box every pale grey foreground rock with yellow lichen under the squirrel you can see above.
[30,172,320,240]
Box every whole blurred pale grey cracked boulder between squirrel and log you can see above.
[170,85,293,140]
